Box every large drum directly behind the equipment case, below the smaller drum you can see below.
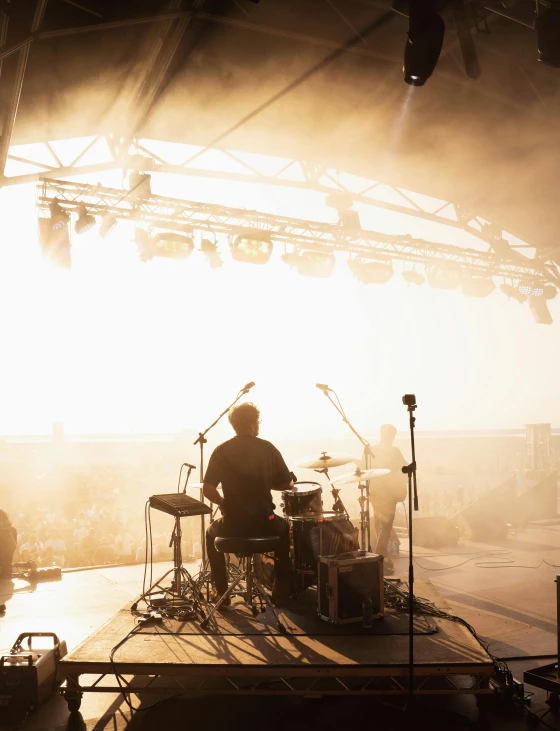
[289,512,358,580]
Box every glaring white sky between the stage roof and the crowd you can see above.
[0,143,560,439]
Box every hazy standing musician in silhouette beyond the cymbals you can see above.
[362,424,408,575]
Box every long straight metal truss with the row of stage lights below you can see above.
[37,179,560,287]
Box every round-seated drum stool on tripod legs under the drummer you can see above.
[200,536,286,633]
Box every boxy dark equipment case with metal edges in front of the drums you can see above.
[317,551,383,624]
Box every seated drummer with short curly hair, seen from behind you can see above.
[203,403,294,603]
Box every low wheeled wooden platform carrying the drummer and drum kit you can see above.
[60,579,495,705]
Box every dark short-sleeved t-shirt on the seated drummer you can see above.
[204,436,292,525]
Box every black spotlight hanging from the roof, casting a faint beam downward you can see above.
[403,8,445,86]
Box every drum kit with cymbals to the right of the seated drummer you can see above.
[256,452,389,590]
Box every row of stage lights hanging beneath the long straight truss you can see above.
[40,200,557,324]
